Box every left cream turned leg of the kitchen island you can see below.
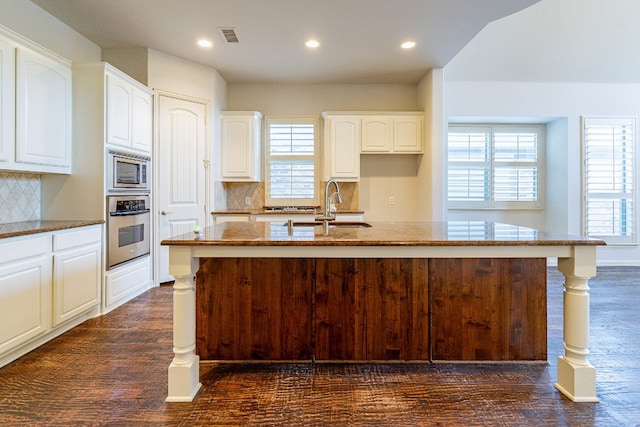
[166,246,202,402]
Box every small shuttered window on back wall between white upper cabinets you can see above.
[265,117,319,206]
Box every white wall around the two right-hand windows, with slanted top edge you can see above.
[444,0,640,265]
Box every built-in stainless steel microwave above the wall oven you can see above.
[107,150,151,193]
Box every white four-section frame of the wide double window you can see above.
[445,123,547,211]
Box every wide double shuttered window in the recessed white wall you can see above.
[447,125,545,209]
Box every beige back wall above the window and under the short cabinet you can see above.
[227,84,423,221]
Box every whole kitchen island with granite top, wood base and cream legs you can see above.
[162,221,604,402]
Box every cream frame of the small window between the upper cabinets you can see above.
[263,116,321,207]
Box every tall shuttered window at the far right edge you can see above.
[582,117,637,244]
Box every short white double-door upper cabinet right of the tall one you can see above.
[361,114,423,154]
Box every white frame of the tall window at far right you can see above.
[580,116,640,246]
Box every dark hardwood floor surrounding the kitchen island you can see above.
[0,267,640,426]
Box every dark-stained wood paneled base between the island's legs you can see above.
[196,258,547,362]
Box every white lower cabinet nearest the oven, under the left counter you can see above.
[53,227,102,326]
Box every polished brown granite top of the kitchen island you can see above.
[161,221,605,246]
